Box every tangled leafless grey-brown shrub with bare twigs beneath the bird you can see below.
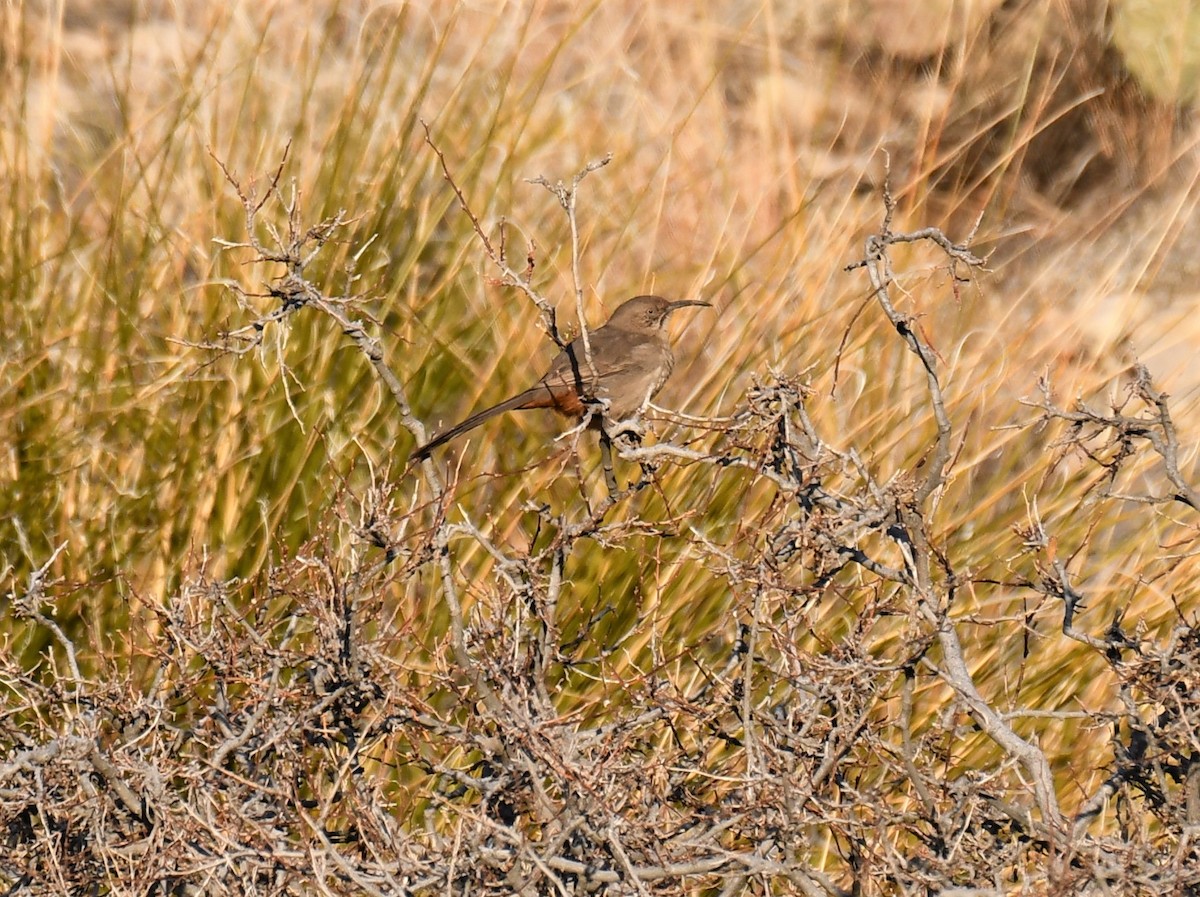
[0,157,1200,896]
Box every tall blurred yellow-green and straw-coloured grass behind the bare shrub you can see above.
[0,0,1200,892]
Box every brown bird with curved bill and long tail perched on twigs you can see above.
[413,296,712,460]
